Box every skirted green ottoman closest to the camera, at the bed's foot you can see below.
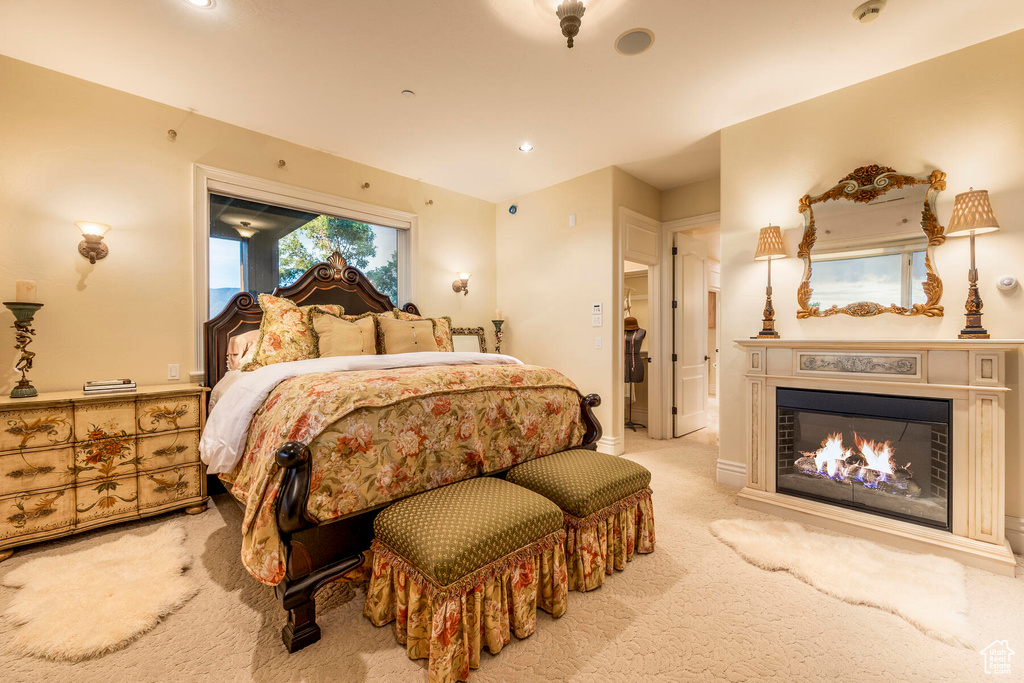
[364,477,568,683]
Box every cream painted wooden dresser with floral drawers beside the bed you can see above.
[0,384,207,561]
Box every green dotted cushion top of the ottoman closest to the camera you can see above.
[374,477,562,587]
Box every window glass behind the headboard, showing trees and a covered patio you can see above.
[208,193,404,317]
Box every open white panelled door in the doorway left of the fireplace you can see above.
[672,233,708,436]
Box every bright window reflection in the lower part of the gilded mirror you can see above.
[810,242,928,310]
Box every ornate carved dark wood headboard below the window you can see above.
[204,252,420,386]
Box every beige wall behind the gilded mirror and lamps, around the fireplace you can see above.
[721,32,1024,517]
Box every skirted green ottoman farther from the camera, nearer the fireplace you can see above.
[508,450,654,591]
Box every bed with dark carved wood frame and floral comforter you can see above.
[204,253,601,652]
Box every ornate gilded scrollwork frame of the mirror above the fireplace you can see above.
[797,165,946,318]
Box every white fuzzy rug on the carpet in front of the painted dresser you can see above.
[3,521,197,661]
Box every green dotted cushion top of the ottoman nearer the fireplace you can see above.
[508,449,650,517]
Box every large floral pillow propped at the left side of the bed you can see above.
[242,294,345,372]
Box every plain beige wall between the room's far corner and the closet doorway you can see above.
[495,167,622,435]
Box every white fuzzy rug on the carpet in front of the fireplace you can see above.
[711,519,972,647]
